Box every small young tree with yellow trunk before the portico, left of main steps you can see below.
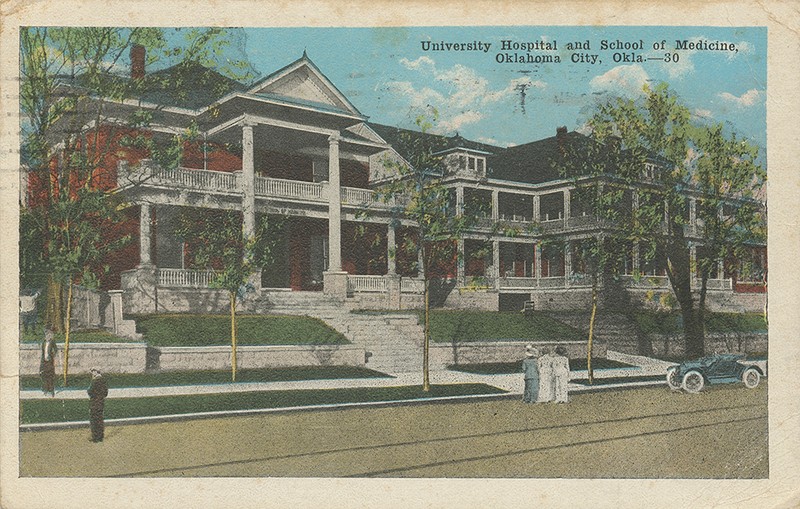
[175,209,282,382]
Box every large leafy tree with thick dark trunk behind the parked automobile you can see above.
[572,84,765,356]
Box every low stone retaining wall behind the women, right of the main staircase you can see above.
[430,341,606,368]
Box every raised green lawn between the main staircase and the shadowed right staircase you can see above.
[420,309,583,343]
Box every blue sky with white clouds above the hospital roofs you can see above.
[239,26,767,156]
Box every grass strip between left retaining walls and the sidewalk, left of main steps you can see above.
[20,366,389,389]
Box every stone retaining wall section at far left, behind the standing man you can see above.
[19,343,147,375]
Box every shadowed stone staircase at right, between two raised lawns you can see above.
[549,310,645,355]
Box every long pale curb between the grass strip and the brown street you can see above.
[19,380,666,433]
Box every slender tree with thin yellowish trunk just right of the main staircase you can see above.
[377,109,478,392]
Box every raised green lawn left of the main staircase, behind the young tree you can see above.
[135,314,349,347]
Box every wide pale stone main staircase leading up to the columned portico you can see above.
[248,291,424,373]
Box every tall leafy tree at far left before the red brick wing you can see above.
[20,27,255,384]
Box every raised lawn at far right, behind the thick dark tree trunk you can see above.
[634,311,767,334]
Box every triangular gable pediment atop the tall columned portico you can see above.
[247,51,364,117]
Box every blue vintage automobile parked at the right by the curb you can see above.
[667,354,764,393]
